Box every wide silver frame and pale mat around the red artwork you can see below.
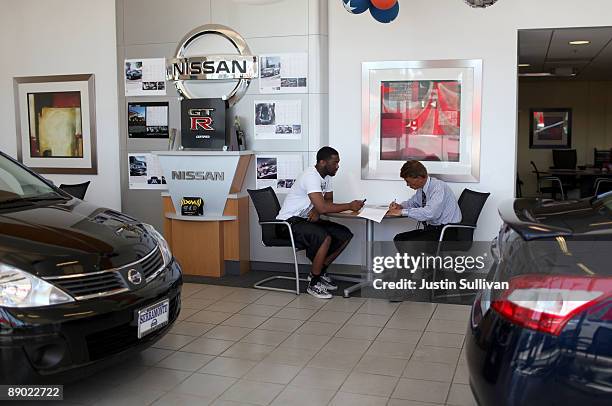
[361,59,482,182]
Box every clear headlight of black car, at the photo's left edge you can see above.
[0,264,74,307]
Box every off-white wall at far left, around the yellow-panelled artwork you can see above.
[0,0,121,209]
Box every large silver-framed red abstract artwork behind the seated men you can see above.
[361,60,482,182]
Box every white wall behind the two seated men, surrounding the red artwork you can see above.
[329,0,612,262]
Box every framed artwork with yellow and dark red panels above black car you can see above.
[13,74,98,174]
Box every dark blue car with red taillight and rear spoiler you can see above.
[465,193,612,406]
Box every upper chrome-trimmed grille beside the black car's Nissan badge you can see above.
[45,246,165,300]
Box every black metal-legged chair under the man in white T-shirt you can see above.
[247,187,307,295]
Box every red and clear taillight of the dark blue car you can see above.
[491,275,612,336]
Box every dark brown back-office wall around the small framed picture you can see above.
[517,80,612,196]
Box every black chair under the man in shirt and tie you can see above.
[432,189,491,299]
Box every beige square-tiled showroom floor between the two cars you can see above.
[52,284,475,406]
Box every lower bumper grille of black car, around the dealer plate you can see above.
[85,295,180,361]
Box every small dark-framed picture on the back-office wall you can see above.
[529,108,572,149]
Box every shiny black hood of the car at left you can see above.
[0,199,156,276]
